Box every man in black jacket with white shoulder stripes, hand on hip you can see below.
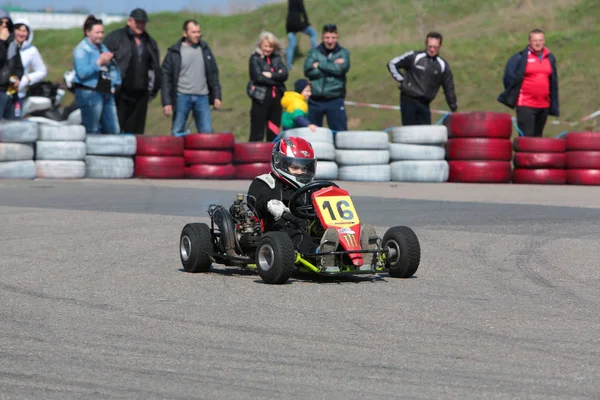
[388,32,458,125]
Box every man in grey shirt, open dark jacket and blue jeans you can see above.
[161,19,221,135]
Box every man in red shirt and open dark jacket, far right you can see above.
[498,29,559,137]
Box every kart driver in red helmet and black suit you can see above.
[248,137,377,268]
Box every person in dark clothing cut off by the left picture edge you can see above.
[0,8,24,119]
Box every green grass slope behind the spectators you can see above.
[34,0,600,141]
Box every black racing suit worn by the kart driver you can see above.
[248,174,318,254]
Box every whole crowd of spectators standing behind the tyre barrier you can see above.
[0,0,559,142]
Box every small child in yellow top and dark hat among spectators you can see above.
[281,79,317,132]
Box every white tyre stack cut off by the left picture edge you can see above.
[0,121,39,179]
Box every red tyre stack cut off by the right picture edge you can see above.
[565,132,600,185]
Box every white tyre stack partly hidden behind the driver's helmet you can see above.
[282,128,338,180]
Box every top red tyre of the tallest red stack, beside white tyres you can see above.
[448,112,512,139]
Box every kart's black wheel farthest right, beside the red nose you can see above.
[383,226,421,278]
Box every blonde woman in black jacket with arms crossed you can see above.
[249,32,288,142]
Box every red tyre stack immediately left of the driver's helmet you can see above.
[233,142,273,179]
